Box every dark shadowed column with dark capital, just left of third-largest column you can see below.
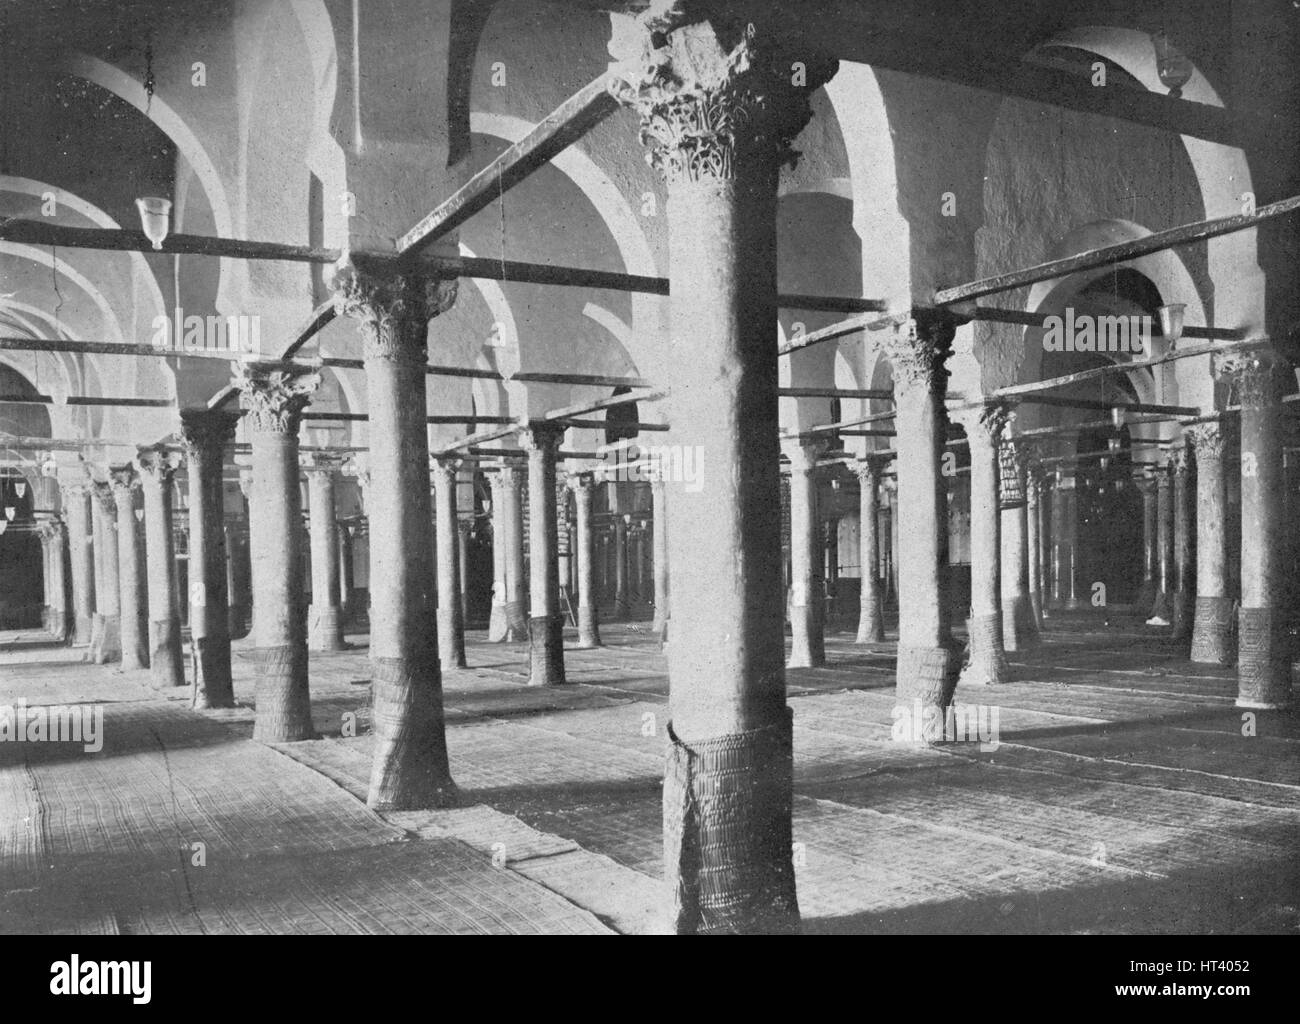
[181,409,239,708]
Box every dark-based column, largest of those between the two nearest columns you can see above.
[520,422,564,686]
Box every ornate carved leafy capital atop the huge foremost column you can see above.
[610,0,839,185]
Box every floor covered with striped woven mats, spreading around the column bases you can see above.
[0,616,1300,933]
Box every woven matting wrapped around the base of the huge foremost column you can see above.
[663,707,800,934]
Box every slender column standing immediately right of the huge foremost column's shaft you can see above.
[785,441,826,668]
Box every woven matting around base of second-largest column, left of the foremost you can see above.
[365,654,459,811]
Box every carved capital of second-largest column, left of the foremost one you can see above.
[332,255,459,365]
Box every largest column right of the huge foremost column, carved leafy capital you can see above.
[884,314,961,722]
